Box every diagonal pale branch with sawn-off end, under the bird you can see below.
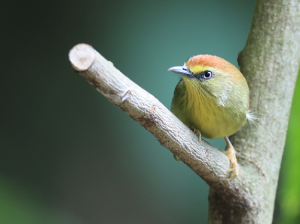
[69,44,249,203]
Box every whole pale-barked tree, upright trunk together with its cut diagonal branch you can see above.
[69,0,300,224]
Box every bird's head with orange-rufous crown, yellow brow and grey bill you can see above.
[168,55,249,104]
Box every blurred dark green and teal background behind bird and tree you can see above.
[0,0,300,224]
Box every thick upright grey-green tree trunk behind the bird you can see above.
[208,0,300,224]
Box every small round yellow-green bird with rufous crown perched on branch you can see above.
[168,55,255,180]
